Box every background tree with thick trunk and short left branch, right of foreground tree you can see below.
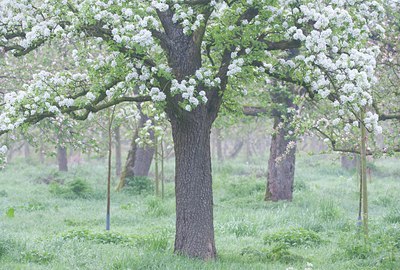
[243,83,300,201]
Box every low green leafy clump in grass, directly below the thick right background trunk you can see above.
[264,228,322,246]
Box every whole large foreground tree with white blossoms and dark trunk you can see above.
[0,0,388,259]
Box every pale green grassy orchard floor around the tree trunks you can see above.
[0,155,400,270]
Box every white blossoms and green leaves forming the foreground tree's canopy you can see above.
[0,0,398,158]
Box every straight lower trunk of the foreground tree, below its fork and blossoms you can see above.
[171,108,216,259]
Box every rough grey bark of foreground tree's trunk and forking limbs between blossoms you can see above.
[158,9,219,260]
